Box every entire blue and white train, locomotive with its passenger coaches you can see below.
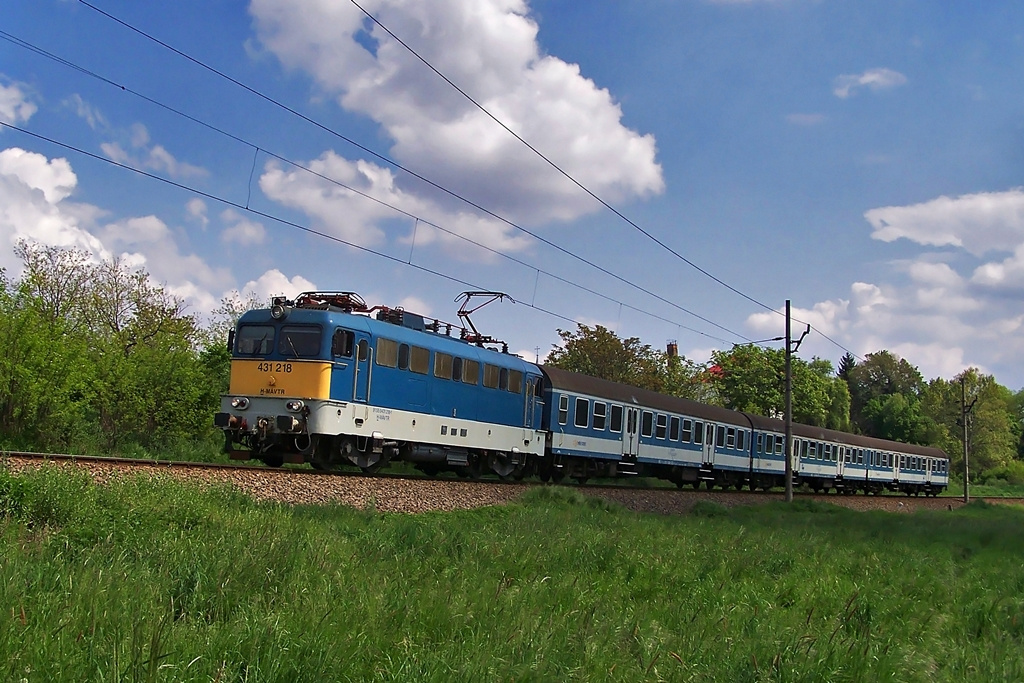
[214,292,949,496]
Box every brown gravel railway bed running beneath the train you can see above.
[0,452,1007,514]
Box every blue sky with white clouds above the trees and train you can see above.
[0,0,1024,390]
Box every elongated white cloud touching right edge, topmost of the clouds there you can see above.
[864,187,1024,256]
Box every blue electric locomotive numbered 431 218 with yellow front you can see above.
[215,292,545,476]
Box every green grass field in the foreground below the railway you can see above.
[0,469,1024,681]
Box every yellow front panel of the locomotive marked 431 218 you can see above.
[230,360,331,398]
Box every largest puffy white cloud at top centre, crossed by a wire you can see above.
[250,0,664,232]
